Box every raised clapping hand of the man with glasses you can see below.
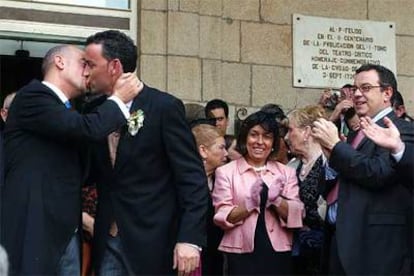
[312,118,341,151]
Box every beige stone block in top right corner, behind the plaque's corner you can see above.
[368,0,414,35]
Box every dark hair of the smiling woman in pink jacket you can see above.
[236,111,280,158]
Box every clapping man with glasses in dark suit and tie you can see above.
[312,64,414,275]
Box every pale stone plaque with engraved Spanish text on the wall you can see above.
[293,14,397,88]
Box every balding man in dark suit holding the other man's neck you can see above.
[1,45,142,275]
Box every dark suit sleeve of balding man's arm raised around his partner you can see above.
[12,88,126,140]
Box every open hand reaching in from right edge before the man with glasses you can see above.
[361,117,404,154]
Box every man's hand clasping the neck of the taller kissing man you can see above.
[112,73,144,103]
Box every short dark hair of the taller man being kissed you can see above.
[86,30,138,73]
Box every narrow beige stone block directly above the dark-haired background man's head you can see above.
[202,60,223,102]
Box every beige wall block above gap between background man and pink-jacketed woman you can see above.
[221,62,251,105]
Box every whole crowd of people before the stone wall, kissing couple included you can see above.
[0,30,414,276]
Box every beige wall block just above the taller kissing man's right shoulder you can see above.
[167,56,201,101]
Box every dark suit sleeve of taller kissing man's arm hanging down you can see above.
[161,98,209,246]
